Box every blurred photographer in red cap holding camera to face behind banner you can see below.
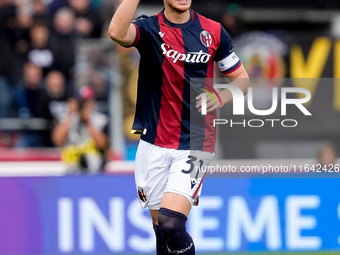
[52,86,108,174]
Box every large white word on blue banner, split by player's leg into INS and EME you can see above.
[57,195,326,253]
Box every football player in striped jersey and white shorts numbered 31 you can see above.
[108,0,249,255]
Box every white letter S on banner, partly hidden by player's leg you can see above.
[127,199,156,253]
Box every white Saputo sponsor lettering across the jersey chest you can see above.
[161,43,211,64]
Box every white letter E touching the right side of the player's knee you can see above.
[189,197,224,251]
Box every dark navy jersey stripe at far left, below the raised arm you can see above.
[132,16,164,144]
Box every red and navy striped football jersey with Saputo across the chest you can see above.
[131,10,241,152]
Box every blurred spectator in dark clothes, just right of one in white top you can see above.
[53,7,76,82]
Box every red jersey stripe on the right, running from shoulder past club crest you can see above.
[198,15,221,152]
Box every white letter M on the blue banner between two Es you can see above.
[227,196,282,251]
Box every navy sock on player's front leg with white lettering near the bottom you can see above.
[158,208,195,255]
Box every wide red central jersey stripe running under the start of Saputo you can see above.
[155,13,185,149]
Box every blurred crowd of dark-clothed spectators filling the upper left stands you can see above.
[0,0,113,147]
